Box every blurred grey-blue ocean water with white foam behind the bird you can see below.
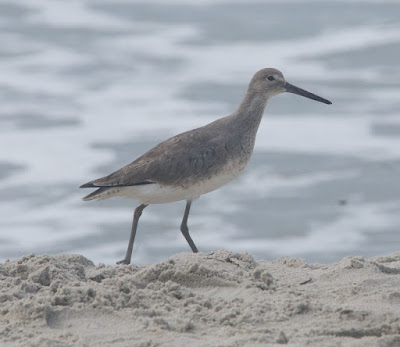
[0,0,400,264]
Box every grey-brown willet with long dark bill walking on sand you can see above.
[80,68,331,264]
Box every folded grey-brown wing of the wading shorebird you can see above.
[81,123,234,188]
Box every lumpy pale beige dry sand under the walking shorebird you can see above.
[0,251,400,347]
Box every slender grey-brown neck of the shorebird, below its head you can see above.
[234,91,268,136]
